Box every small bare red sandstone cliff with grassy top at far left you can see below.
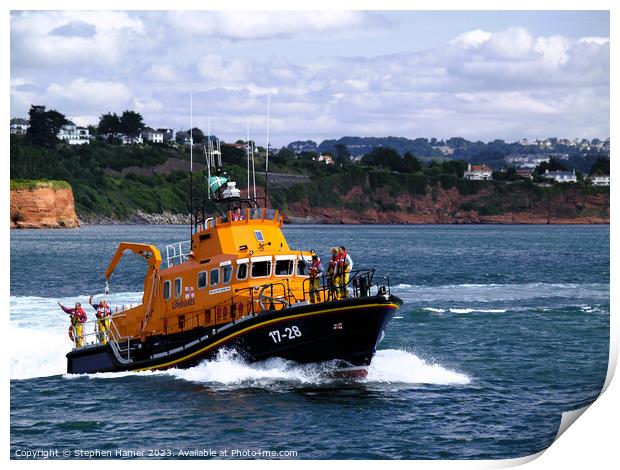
[11,183,80,228]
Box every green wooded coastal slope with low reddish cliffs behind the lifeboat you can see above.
[10,135,609,229]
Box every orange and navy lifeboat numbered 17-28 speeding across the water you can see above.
[67,140,402,376]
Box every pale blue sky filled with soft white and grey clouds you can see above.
[10,11,610,147]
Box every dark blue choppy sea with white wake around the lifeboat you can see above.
[11,226,609,459]
